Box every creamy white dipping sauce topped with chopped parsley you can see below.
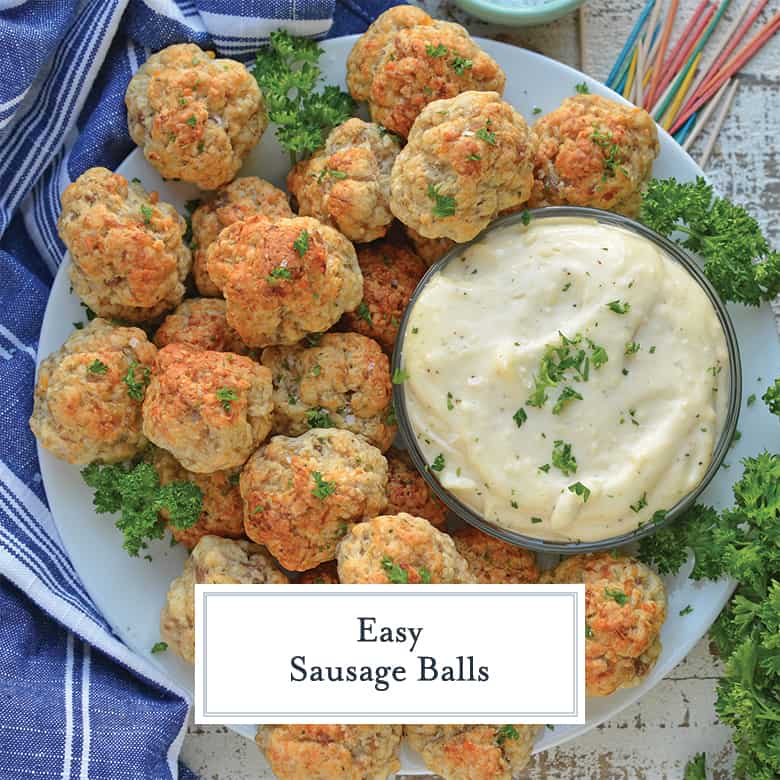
[402,217,729,541]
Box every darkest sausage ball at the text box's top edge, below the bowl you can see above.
[452,526,539,585]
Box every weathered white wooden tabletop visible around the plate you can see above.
[182,0,780,780]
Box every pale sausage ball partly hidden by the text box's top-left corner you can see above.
[160,536,288,663]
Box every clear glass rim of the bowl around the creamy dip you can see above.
[391,206,742,554]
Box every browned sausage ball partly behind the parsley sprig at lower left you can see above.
[147,447,244,550]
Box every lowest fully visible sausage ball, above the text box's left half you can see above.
[240,428,387,571]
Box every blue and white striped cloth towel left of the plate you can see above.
[0,0,394,780]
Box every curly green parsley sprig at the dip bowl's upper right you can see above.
[640,177,780,306]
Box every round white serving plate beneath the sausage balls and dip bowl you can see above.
[38,36,780,773]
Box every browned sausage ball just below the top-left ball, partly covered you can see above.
[191,176,293,297]
